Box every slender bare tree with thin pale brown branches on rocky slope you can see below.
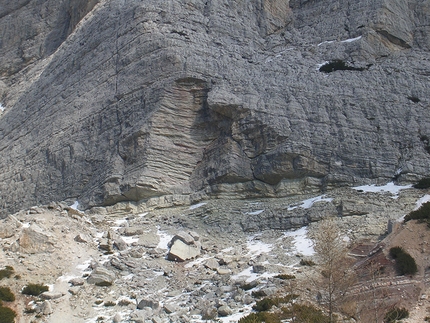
[310,218,355,322]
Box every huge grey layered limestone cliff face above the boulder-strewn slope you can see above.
[0,0,430,215]
